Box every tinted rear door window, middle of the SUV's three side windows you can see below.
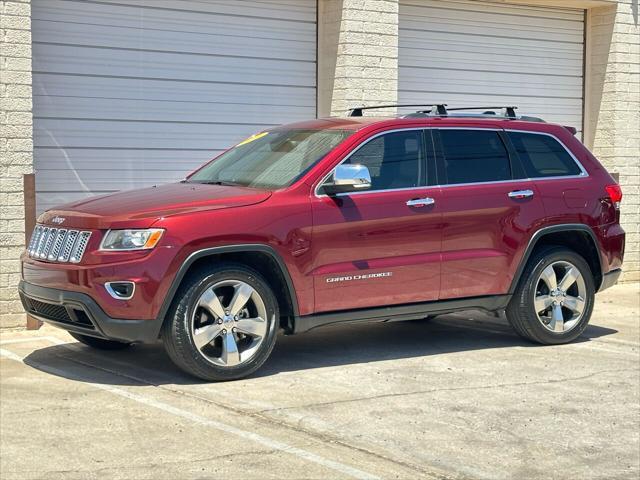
[440,129,511,184]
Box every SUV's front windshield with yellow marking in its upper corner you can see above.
[186,130,352,189]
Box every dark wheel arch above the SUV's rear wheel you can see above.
[509,223,603,294]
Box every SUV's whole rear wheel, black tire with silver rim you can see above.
[507,247,595,345]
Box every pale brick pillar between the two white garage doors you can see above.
[318,0,398,116]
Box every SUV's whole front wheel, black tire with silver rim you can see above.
[162,263,278,381]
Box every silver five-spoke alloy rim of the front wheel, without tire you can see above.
[191,280,268,367]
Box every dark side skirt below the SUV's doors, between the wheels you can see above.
[293,295,511,334]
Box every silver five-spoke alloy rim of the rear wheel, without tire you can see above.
[533,260,587,333]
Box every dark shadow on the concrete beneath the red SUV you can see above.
[25,314,617,386]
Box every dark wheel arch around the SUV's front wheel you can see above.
[158,244,299,331]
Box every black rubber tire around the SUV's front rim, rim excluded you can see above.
[162,263,279,381]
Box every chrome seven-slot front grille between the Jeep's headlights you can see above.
[27,225,91,263]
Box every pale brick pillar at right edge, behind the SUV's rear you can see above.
[585,0,640,281]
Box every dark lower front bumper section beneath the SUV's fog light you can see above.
[18,280,161,343]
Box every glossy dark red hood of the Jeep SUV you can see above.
[38,183,271,229]
